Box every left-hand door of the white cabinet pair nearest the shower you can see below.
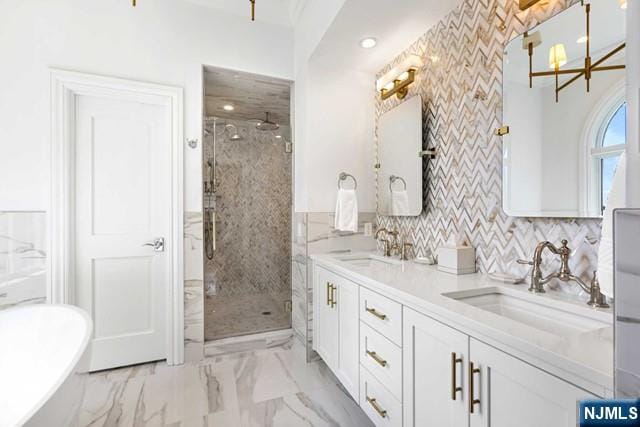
[313,267,338,372]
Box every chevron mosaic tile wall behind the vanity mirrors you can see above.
[375,0,601,292]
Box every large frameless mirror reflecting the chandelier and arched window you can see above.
[503,0,626,218]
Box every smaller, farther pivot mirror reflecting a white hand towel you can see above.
[377,96,422,216]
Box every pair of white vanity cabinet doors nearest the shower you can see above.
[313,266,360,401]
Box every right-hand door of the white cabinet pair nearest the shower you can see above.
[335,279,360,402]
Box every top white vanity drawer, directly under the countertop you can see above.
[360,287,402,346]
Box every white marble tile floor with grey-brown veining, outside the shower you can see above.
[79,341,372,427]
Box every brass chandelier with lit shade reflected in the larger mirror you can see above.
[521,1,626,102]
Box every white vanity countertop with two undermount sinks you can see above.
[311,254,613,397]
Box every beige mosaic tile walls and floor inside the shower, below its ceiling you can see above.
[204,120,292,340]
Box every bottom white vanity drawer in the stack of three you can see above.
[360,368,402,427]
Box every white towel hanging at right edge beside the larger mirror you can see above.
[598,153,627,298]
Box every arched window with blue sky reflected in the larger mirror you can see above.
[591,102,627,212]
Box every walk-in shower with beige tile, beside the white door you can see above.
[203,68,292,341]
